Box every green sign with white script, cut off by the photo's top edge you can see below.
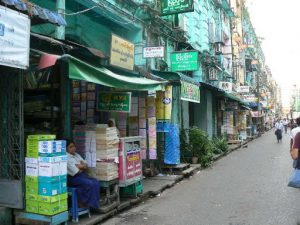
[161,0,194,16]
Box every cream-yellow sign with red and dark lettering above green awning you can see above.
[110,34,134,70]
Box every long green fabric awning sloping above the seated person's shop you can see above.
[60,55,167,91]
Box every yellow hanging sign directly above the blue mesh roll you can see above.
[156,86,172,120]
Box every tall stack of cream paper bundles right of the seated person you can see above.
[90,124,119,181]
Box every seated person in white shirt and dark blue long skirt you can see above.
[66,140,100,209]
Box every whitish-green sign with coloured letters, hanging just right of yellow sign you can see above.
[180,81,200,103]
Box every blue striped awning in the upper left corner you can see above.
[0,0,67,26]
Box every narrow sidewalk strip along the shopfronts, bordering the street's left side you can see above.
[69,137,251,225]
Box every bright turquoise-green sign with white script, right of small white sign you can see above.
[171,51,199,72]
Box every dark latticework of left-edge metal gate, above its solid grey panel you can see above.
[0,70,24,180]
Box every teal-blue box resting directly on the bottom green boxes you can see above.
[39,180,67,196]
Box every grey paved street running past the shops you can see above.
[103,131,300,225]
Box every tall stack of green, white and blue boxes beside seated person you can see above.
[25,135,68,216]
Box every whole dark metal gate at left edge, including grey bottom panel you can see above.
[0,67,24,208]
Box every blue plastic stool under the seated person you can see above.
[68,187,91,223]
